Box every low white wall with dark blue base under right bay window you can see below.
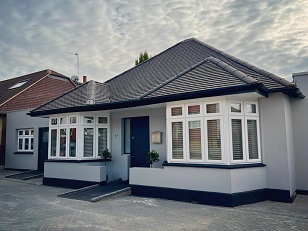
[129,165,284,207]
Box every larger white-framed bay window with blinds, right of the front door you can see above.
[167,99,261,164]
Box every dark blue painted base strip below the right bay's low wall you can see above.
[130,185,294,207]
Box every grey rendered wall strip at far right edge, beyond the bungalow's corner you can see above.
[292,72,308,190]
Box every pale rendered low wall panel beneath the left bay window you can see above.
[44,162,106,182]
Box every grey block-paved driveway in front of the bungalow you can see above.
[0,171,308,230]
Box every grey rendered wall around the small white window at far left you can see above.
[5,110,48,170]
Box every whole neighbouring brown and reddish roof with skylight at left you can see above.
[0,69,76,114]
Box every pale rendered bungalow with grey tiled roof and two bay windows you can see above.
[29,38,308,206]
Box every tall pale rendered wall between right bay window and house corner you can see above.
[259,93,296,195]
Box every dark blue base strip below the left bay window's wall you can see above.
[43,177,106,189]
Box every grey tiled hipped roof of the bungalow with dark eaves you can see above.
[30,38,304,116]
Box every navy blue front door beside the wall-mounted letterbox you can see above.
[130,116,150,167]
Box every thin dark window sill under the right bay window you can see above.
[163,161,266,169]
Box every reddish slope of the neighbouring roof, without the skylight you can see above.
[0,77,75,111]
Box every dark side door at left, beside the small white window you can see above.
[37,127,49,172]
